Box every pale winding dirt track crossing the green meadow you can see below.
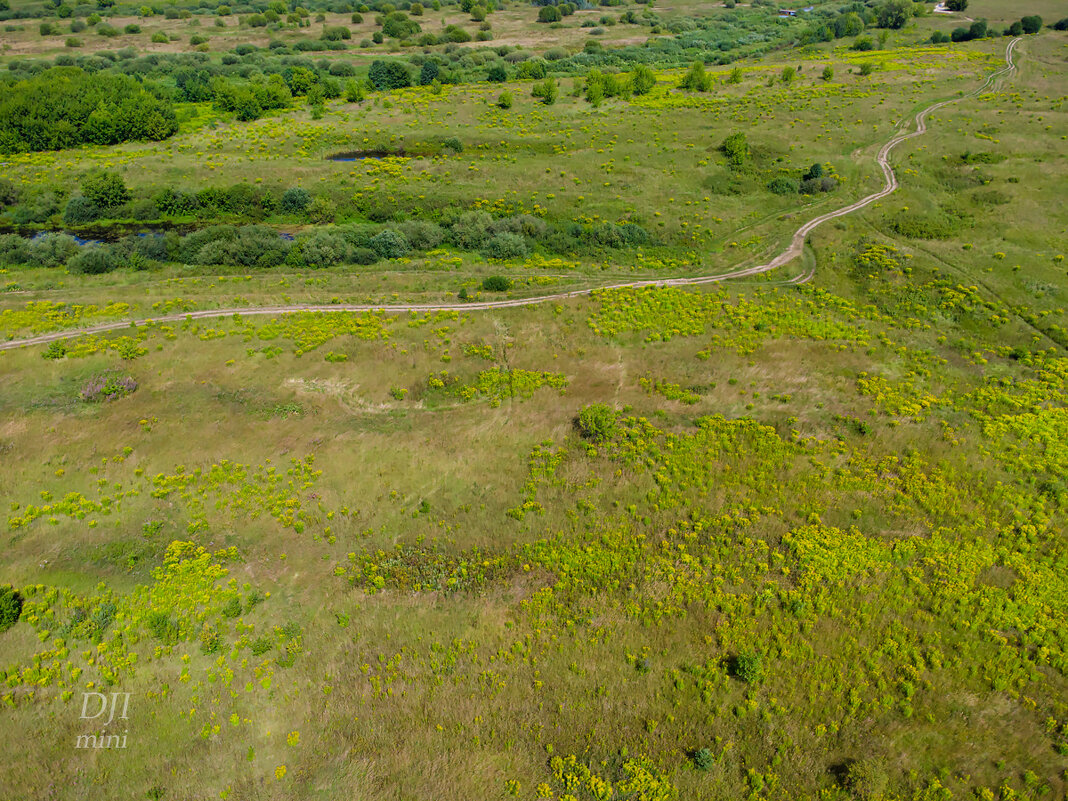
[0,37,1021,350]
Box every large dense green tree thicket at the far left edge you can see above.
[0,67,178,153]
